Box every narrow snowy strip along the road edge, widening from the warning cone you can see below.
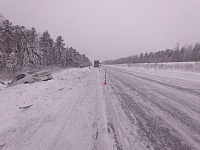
[101,68,145,150]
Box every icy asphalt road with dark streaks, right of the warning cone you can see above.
[106,67,200,150]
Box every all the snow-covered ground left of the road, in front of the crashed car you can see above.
[0,68,108,150]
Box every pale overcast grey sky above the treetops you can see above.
[0,0,200,61]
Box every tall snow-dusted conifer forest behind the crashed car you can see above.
[0,14,91,72]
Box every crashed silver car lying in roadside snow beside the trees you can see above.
[8,70,53,86]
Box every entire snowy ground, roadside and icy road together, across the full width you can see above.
[0,66,200,150]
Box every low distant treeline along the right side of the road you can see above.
[102,43,200,65]
